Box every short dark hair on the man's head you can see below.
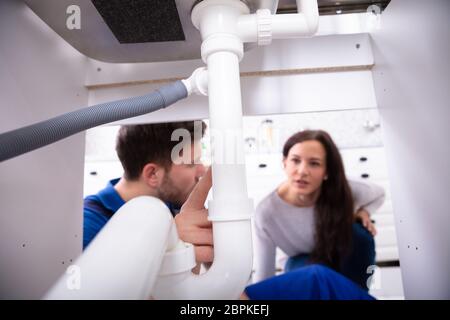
[116,121,206,180]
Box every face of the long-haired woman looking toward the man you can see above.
[283,140,327,195]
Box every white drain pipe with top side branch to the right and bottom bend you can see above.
[153,0,319,299]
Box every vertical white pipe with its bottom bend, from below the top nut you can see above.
[153,51,253,299]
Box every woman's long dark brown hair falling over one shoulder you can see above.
[283,130,354,270]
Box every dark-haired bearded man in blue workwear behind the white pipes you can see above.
[83,121,213,263]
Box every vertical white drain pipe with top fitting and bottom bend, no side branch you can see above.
[153,0,253,299]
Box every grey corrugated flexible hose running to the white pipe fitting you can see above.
[0,81,188,162]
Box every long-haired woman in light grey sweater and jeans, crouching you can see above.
[254,130,384,289]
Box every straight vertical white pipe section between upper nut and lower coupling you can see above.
[207,52,247,201]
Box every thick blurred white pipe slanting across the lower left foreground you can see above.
[44,196,178,299]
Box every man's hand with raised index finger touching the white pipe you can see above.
[175,169,214,262]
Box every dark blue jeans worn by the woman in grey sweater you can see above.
[284,222,375,290]
